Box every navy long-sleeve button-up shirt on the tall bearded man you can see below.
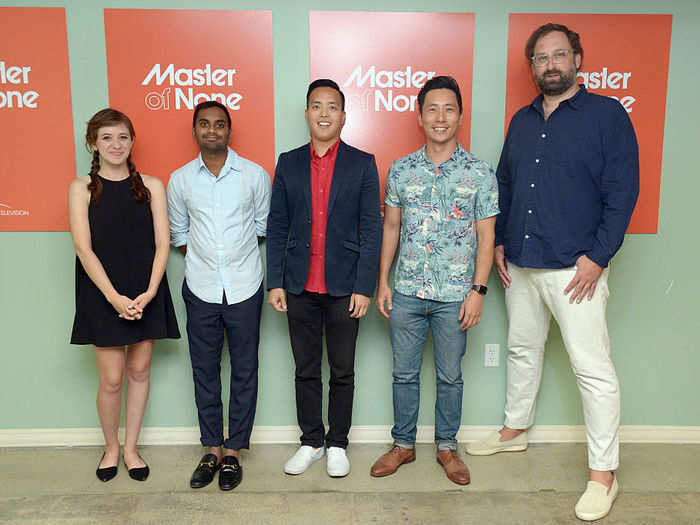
[496,86,639,268]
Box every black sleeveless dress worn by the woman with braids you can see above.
[70,177,180,346]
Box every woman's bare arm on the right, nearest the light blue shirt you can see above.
[132,175,170,313]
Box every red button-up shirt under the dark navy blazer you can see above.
[304,139,340,293]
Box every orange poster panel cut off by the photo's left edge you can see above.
[0,7,75,231]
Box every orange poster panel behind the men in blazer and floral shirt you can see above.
[309,11,474,202]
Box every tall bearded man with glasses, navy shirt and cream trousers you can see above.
[467,24,639,520]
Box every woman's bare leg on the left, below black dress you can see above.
[95,346,126,468]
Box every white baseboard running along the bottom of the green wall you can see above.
[0,425,700,447]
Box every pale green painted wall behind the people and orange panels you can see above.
[0,0,700,429]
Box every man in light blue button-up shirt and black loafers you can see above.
[168,101,270,490]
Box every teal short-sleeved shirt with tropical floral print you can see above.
[384,144,498,302]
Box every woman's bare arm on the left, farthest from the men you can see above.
[68,177,137,320]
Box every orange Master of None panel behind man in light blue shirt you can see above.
[104,9,275,184]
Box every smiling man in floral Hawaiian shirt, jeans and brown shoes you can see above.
[370,76,498,485]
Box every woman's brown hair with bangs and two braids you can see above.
[85,108,151,202]
